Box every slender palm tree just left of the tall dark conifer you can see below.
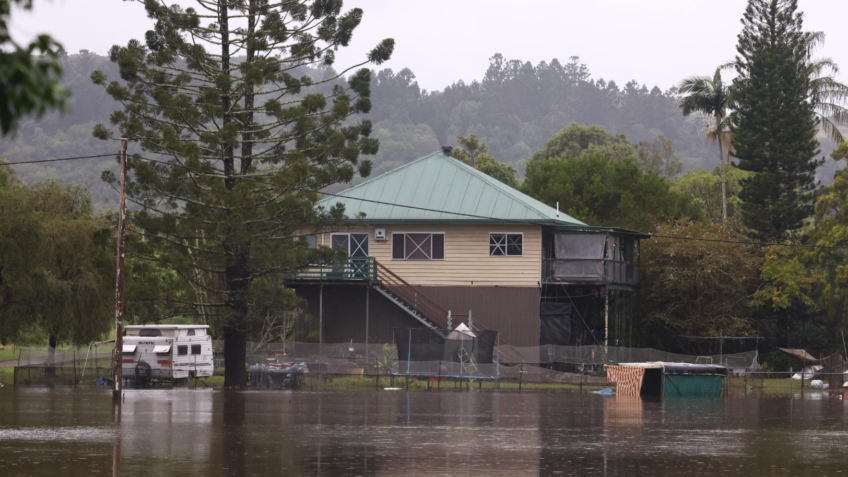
[678,68,732,219]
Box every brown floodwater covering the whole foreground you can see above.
[0,387,848,476]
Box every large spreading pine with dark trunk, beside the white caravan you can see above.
[92,0,394,386]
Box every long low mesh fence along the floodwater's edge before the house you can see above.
[15,340,760,386]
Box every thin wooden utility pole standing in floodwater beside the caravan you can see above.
[112,138,127,402]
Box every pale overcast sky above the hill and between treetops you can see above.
[12,0,848,90]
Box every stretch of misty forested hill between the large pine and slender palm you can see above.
[370,55,718,175]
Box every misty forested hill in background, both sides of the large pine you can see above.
[0,52,833,208]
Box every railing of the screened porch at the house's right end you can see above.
[542,258,639,285]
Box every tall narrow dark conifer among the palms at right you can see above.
[733,0,822,239]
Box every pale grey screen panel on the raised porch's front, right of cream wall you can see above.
[551,234,606,278]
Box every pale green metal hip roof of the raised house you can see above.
[317,152,586,226]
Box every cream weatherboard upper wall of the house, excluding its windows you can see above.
[316,224,542,288]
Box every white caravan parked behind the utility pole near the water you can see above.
[121,325,214,382]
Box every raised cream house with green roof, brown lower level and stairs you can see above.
[287,148,647,346]
